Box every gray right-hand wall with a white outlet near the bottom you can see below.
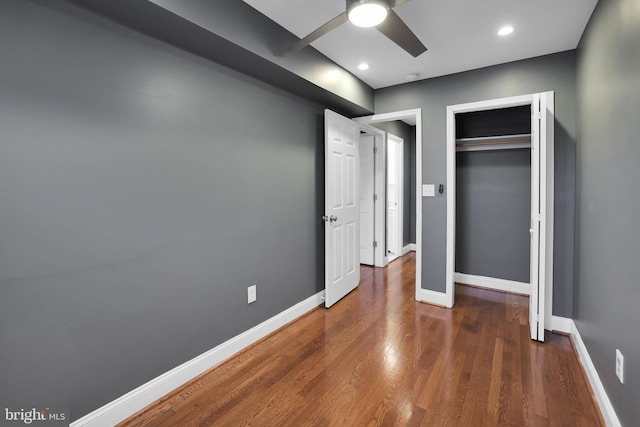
[575,0,640,426]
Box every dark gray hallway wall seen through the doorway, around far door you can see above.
[374,120,416,246]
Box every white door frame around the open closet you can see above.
[445,92,554,334]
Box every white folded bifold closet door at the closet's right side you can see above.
[529,94,547,341]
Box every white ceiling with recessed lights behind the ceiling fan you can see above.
[244,0,598,89]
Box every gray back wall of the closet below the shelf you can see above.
[456,149,531,283]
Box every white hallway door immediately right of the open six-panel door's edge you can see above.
[358,135,375,265]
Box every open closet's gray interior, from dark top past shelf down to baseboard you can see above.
[455,105,531,283]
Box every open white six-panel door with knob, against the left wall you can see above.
[323,110,360,307]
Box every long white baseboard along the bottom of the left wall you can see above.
[70,291,324,427]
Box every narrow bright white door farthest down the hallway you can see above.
[387,135,403,261]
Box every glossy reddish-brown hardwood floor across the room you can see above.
[120,252,604,427]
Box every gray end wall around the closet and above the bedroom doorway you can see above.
[376,51,576,317]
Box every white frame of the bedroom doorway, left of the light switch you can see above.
[353,108,424,301]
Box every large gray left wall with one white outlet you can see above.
[0,0,324,419]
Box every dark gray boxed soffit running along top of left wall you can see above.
[71,0,374,116]
